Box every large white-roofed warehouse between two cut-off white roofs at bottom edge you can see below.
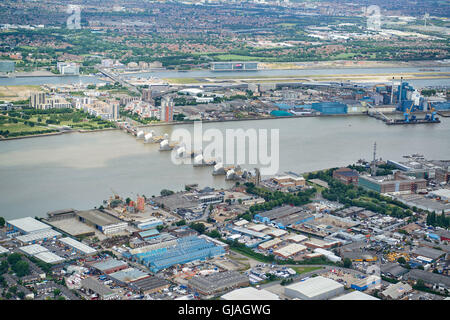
[284,276,344,300]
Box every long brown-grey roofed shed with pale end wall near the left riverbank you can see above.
[76,210,128,234]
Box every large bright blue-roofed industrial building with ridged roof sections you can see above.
[130,236,225,272]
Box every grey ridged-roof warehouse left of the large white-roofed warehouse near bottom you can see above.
[188,271,249,295]
